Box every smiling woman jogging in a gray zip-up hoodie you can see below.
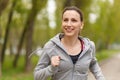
[34,6,105,80]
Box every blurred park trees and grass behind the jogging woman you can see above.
[0,0,120,80]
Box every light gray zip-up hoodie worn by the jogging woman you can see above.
[34,33,105,80]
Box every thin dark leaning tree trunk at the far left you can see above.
[1,0,16,63]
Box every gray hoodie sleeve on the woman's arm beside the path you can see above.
[90,41,105,80]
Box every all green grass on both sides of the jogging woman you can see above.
[0,50,120,80]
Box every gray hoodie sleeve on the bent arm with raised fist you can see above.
[34,42,57,80]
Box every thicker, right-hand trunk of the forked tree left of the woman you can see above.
[25,3,38,72]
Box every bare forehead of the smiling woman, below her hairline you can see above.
[63,10,80,18]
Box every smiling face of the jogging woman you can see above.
[62,10,83,36]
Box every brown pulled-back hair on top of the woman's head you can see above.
[62,6,83,22]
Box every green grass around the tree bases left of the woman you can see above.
[0,56,39,80]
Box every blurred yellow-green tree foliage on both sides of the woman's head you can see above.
[0,0,120,49]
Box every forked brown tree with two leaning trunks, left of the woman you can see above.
[13,0,47,71]
